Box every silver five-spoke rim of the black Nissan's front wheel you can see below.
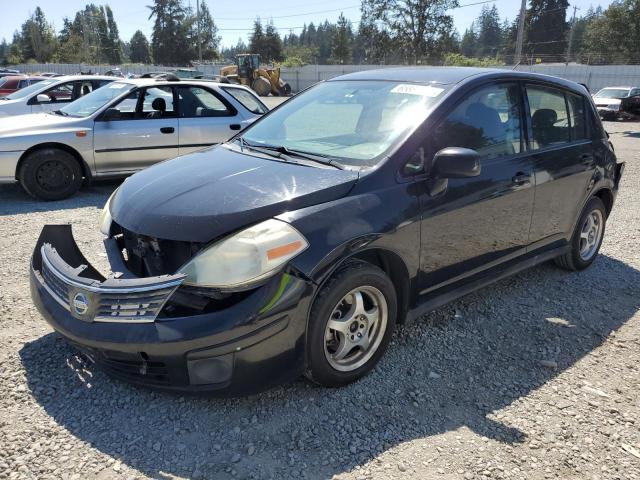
[324,286,389,372]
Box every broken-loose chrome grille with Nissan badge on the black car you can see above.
[32,225,184,323]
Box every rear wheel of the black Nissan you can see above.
[554,197,607,271]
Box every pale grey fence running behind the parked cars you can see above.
[8,63,640,92]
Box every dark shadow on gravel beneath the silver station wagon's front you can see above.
[0,180,122,216]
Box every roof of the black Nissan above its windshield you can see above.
[334,67,504,85]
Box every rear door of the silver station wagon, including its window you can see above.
[176,85,244,155]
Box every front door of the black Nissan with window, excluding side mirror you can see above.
[420,83,534,294]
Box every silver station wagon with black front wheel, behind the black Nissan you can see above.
[0,79,268,200]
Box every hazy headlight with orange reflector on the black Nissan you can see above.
[179,219,309,289]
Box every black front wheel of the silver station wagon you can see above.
[18,148,82,201]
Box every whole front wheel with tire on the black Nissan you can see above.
[305,261,397,387]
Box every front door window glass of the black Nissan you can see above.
[433,84,522,158]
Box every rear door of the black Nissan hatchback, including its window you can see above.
[525,84,595,248]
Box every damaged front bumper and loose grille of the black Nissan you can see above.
[31,224,314,395]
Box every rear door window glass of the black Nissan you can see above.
[527,85,568,150]
